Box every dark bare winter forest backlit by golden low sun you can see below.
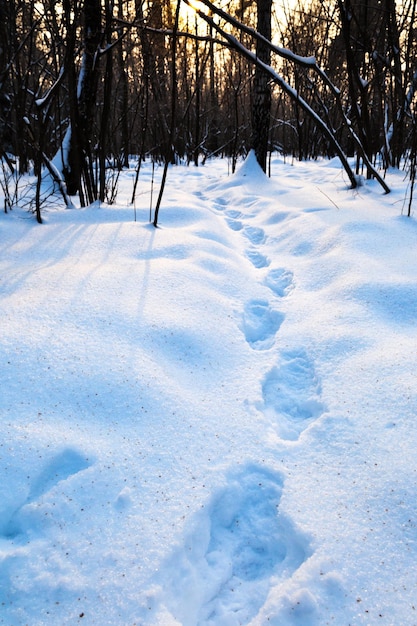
[0,0,417,222]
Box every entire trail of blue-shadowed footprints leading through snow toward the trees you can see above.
[154,158,325,626]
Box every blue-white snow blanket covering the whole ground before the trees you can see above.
[0,155,417,626]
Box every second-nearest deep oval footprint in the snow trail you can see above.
[259,350,326,440]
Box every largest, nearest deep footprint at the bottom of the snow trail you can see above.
[161,465,310,626]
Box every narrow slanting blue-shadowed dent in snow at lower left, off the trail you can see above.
[1,448,90,539]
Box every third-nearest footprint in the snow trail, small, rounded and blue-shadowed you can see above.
[241,300,285,350]
